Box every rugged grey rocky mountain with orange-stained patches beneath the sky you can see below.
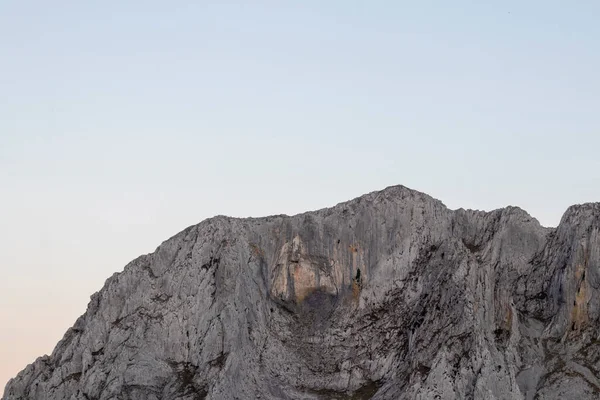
[3,186,600,400]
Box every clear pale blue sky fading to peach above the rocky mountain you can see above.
[0,0,600,391]
